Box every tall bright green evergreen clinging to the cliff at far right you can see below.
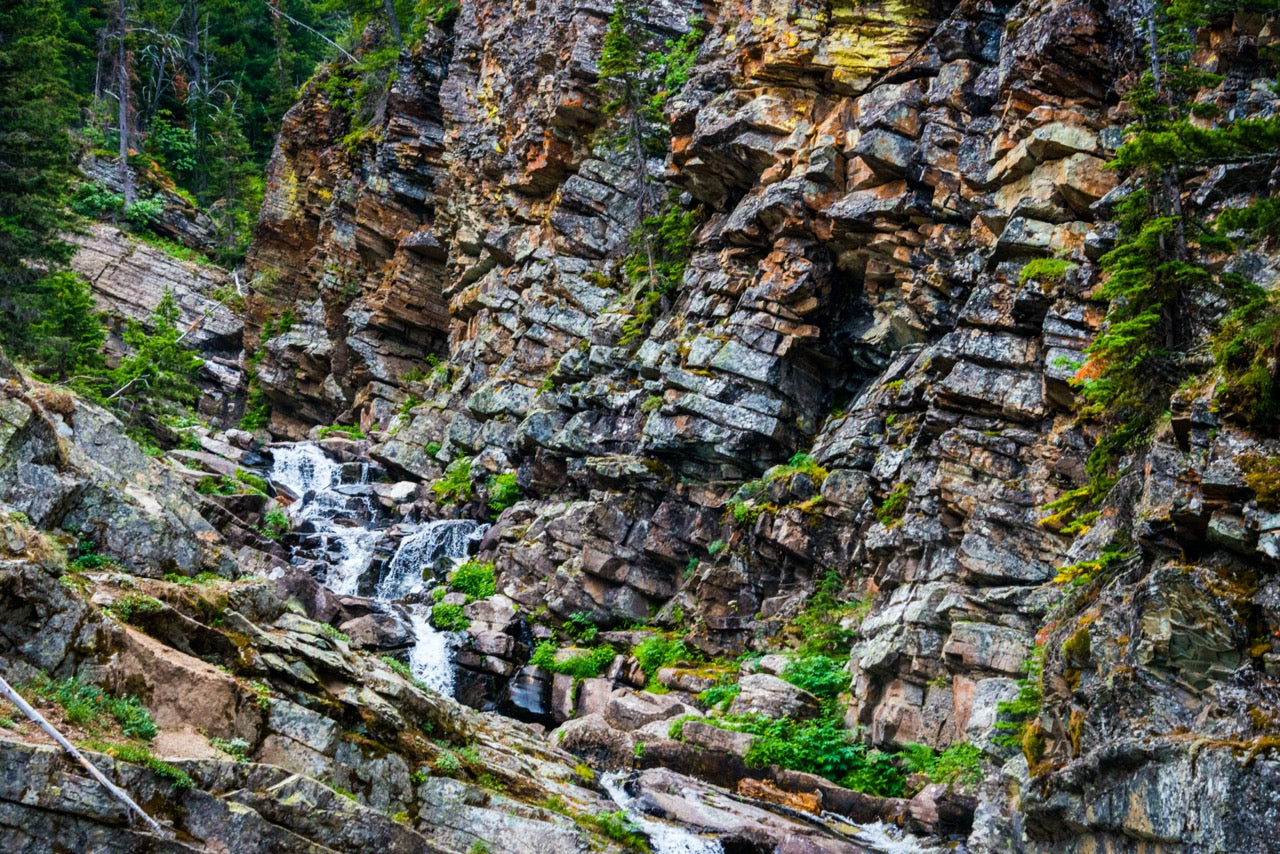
[1076,0,1280,491]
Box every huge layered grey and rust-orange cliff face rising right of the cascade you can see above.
[248,0,1280,850]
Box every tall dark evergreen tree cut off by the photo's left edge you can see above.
[0,0,70,353]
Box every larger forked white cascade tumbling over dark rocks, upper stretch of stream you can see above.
[270,442,485,697]
